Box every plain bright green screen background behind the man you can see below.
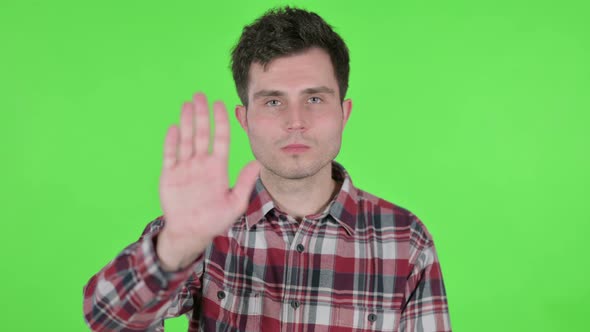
[0,0,590,331]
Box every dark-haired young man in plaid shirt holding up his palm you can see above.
[84,7,451,331]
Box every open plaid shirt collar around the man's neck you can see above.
[244,161,359,234]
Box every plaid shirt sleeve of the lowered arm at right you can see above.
[399,214,451,332]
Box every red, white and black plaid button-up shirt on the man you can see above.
[84,161,451,332]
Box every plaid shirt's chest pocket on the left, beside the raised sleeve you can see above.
[201,278,262,332]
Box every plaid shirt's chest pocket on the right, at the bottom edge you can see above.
[334,306,400,331]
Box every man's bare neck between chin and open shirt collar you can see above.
[260,163,339,221]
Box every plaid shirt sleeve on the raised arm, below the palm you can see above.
[84,216,203,331]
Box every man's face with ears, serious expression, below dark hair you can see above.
[236,48,352,179]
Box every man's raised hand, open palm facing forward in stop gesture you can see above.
[156,93,260,270]
